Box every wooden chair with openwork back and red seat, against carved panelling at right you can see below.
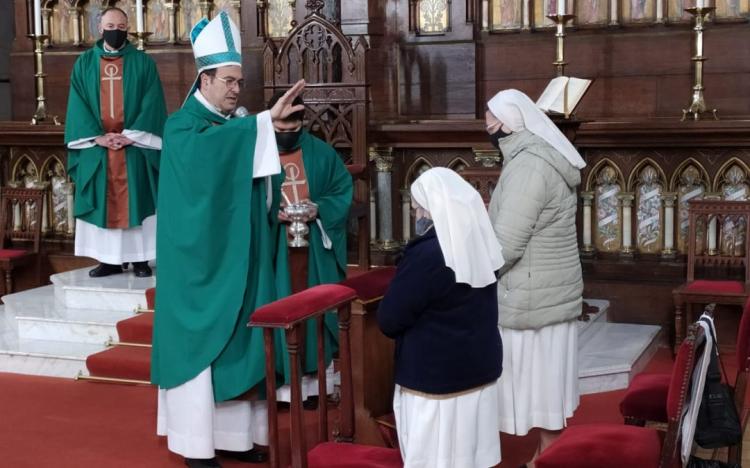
[672,200,750,348]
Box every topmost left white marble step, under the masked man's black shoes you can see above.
[50,267,156,311]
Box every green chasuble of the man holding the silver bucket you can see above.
[274,131,353,383]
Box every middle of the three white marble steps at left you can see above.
[3,285,134,344]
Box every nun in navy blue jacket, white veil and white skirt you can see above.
[378,168,503,468]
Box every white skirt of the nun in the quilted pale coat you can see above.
[496,320,580,436]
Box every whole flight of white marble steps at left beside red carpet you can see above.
[0,268,155,377]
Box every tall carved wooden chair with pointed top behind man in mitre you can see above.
[263,12,370,269]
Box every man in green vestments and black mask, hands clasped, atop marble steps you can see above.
[65,8,167,277]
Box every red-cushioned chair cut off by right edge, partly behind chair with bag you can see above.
[620,300,750,463]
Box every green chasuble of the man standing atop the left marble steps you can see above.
[65,40,167,228]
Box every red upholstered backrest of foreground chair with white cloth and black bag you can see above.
[659,324,705,468]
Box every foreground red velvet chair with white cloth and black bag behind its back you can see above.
[536,325,705,468]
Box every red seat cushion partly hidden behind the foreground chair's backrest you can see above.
[620,374,671,422]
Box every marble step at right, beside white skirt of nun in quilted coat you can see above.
[578,322,661,394]
